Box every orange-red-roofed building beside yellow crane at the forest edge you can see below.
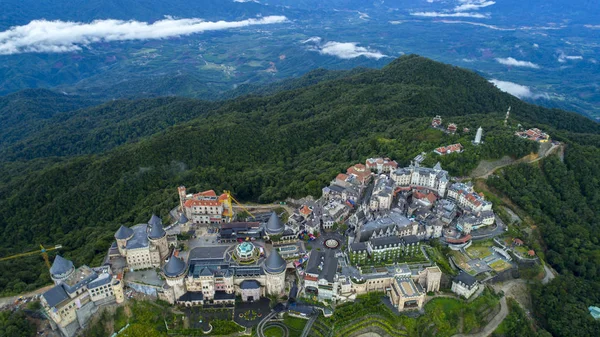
[178,186,233,224]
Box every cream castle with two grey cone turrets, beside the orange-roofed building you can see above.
[115,215,169,270]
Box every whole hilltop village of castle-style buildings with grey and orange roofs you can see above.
[36,116,548,336]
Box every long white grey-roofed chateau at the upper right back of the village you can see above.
[390,163,450,197]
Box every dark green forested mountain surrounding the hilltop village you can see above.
[0,55,600,335]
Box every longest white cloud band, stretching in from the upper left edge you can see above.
[0,16,287,55]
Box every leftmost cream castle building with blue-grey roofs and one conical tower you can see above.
[41,255,125,337]
